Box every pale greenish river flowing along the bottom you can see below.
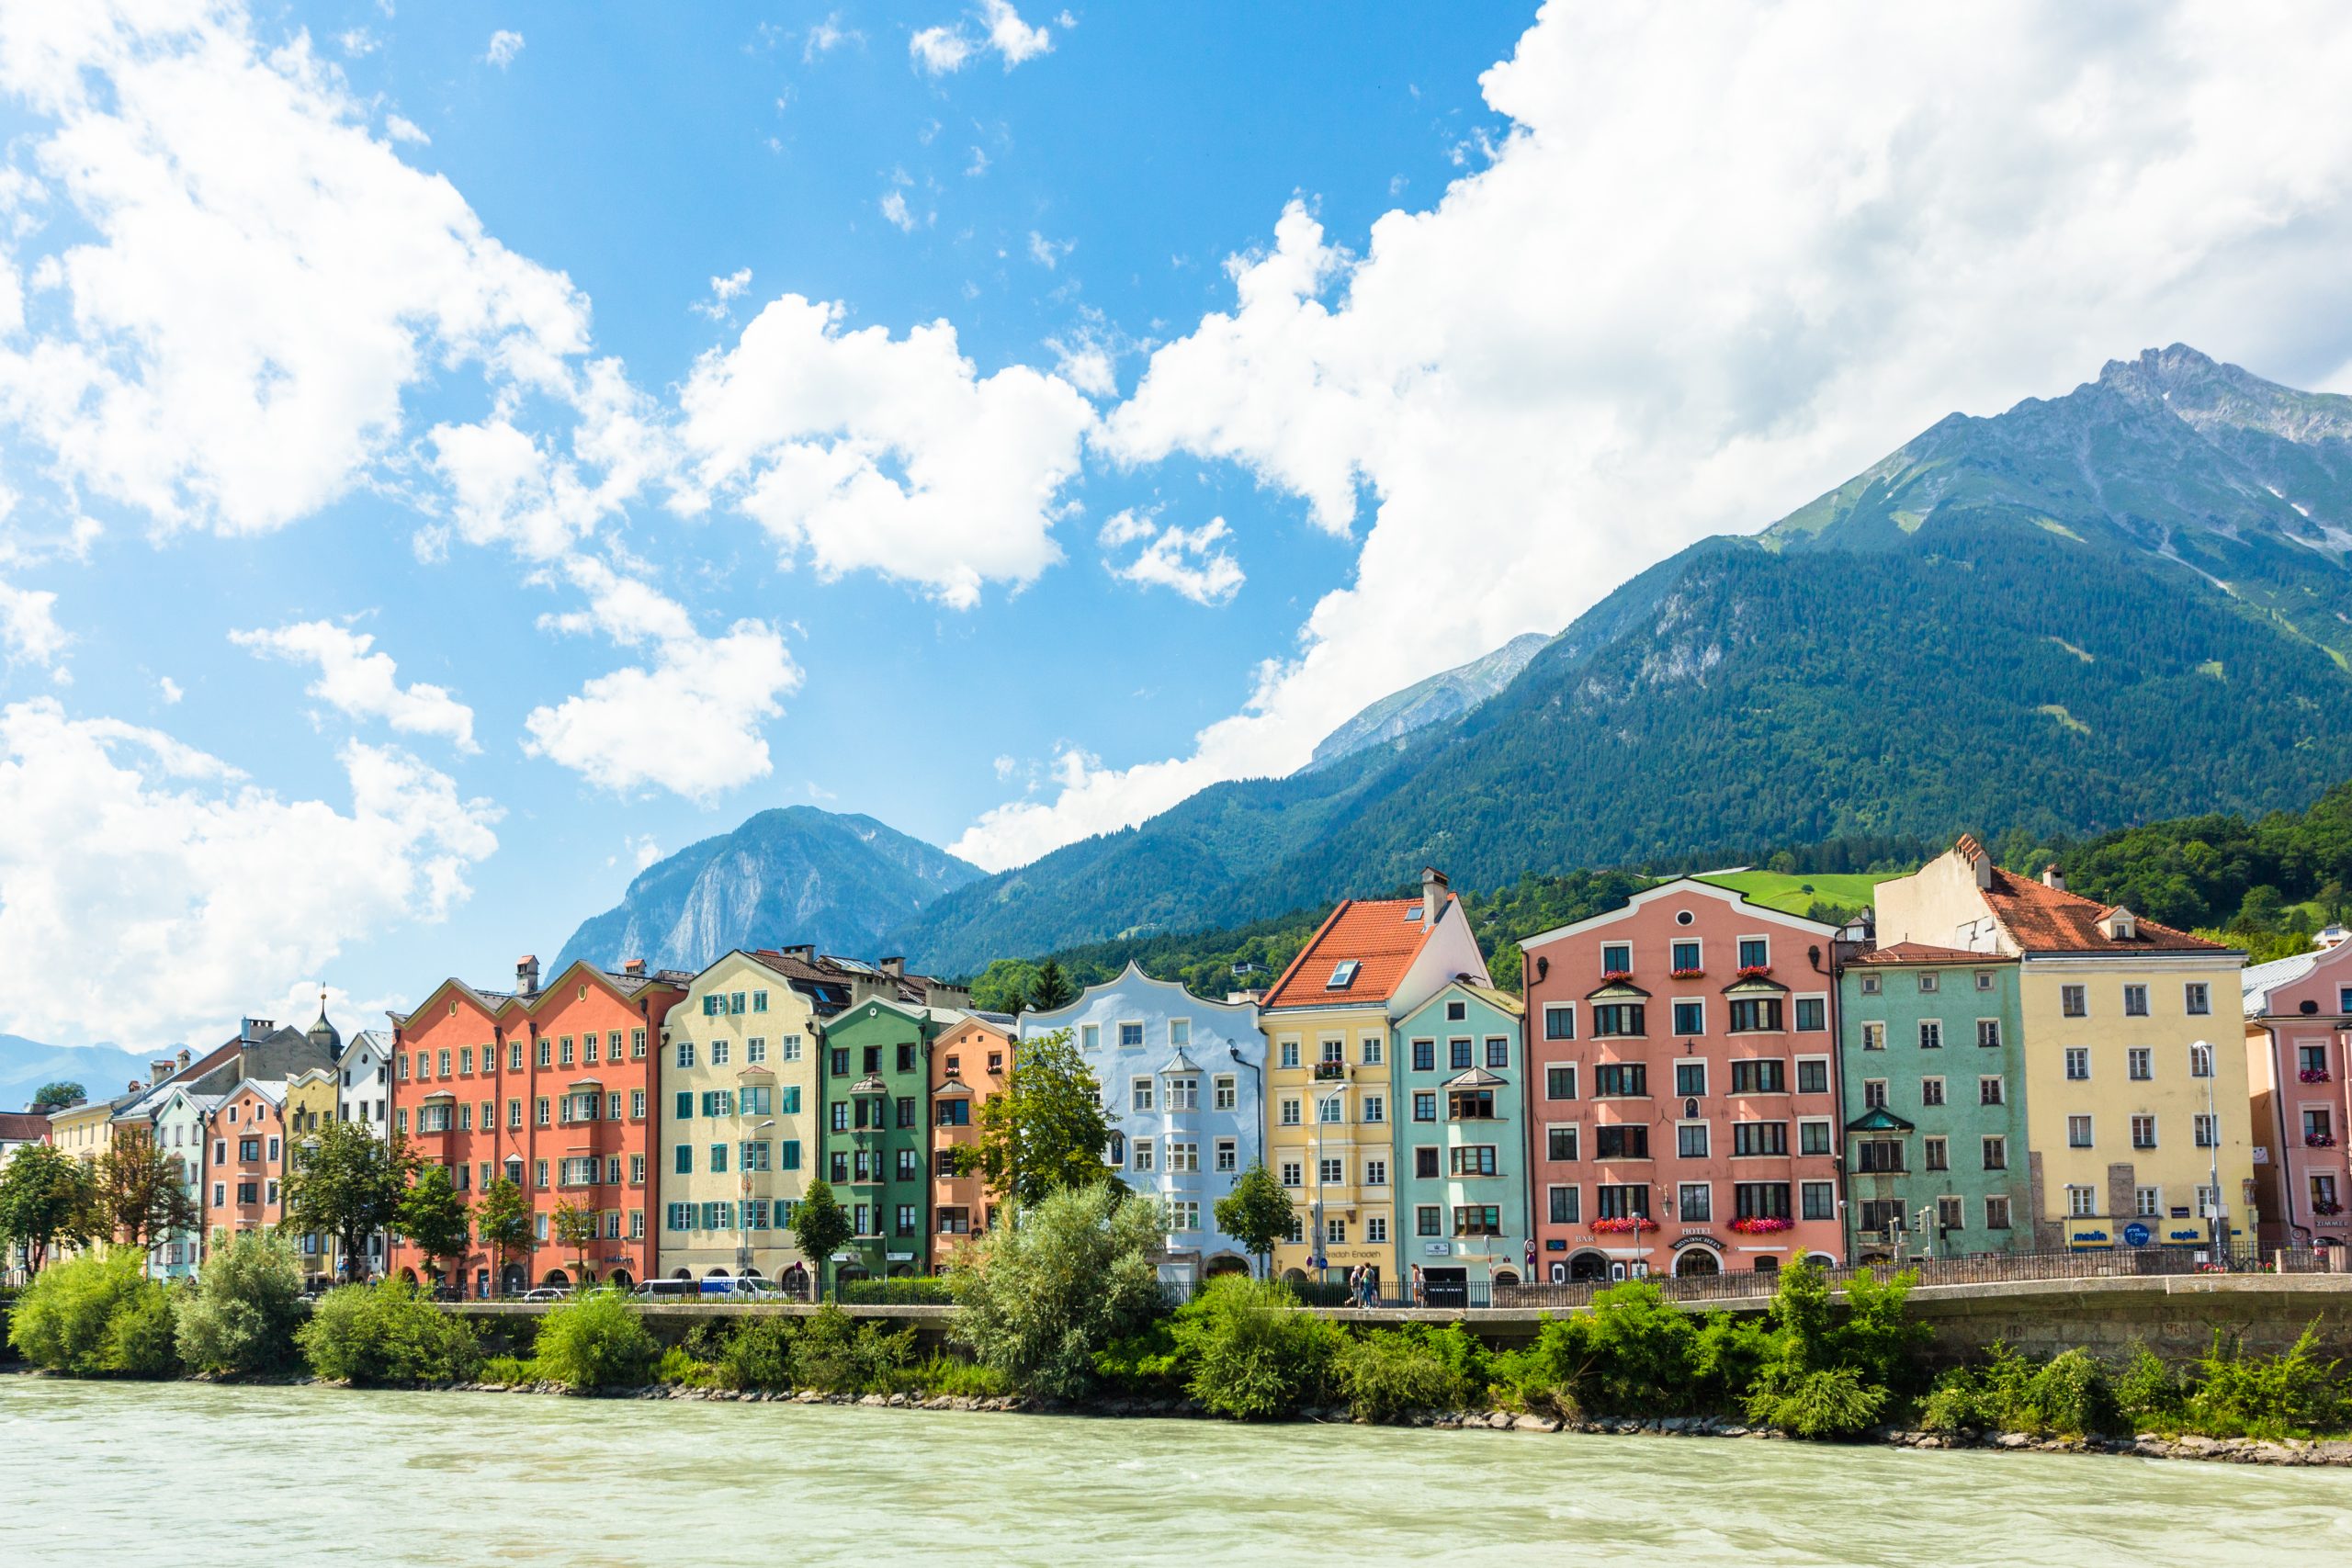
[0,1378,2352,1568]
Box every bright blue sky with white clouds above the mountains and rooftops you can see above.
[0,0,2352,1043]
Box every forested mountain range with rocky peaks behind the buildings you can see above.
[560,345,2352,974]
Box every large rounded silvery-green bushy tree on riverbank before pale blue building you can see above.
[948,1180,1167,1399]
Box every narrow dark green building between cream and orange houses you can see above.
[819,997,945,1279]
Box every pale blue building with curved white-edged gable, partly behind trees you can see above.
[1021,962,1261,1283]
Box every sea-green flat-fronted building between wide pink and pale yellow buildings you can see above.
[1837,942,2034,1262]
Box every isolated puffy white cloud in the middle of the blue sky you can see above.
[677,294,1096,606]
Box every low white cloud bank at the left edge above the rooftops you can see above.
[0,698,499,1046]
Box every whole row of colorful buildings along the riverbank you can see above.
[18,837,2352,1304]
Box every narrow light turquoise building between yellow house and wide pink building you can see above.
[1390,980,1536,1307]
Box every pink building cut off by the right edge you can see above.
[2242,941,2352,1246]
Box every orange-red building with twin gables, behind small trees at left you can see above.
[388,957,692,1295]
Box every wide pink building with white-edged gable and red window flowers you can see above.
[1520,877,1844,1281]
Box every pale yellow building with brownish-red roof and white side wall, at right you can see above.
[1877,837,2258,1248]
